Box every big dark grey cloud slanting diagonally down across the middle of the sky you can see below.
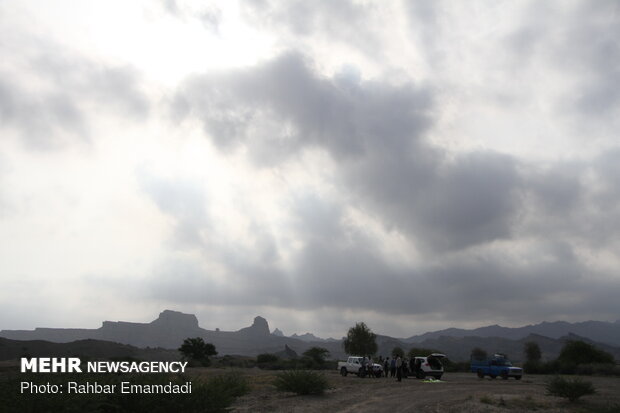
[172,54,519,250]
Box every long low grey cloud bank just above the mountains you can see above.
[145,181,620,321]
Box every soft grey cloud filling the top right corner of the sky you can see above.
[507,1,620,118]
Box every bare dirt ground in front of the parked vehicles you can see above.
[200,369,620,413]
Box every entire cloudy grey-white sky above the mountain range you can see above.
[0,0,620,337]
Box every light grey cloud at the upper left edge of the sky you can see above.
[0,37,149,149]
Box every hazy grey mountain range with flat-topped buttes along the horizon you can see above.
[0,310,620,361]
